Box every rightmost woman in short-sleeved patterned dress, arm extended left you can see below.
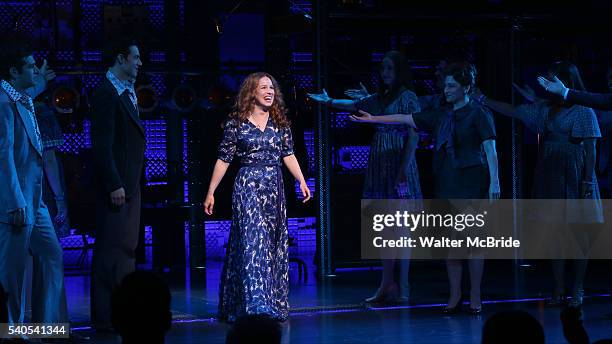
[481,62,603,306]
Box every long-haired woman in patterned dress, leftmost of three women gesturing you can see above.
[309,51,423,302]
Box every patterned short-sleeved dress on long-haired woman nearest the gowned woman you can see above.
[355,90,423,199]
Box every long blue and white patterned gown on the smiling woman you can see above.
[219,119,293,322]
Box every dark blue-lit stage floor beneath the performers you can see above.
[66,261,612,343]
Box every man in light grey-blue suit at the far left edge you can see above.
[0,37,68,323]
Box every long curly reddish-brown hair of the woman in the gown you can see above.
[230,72,291,128]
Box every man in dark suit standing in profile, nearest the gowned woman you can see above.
[91,40,145,331]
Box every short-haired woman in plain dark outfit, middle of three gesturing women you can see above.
[351,63,500,314]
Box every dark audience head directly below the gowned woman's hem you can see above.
[225,314,282,344]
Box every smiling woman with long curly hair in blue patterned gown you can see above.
[204,73,310,322]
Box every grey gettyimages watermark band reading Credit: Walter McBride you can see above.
[361,199,612,259]
